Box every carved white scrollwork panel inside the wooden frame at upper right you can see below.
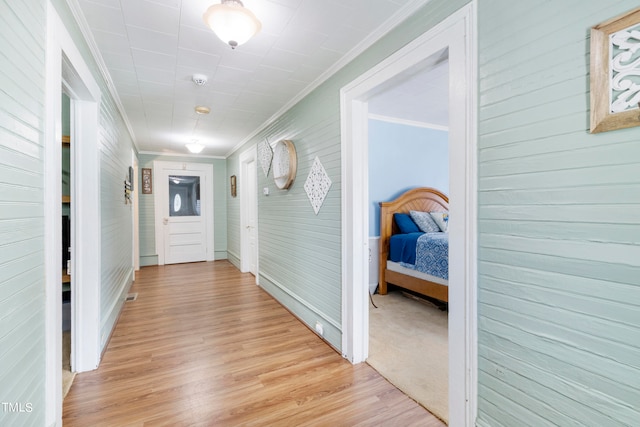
[609,25,640,113]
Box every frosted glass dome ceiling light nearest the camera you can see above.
[203,0,262,49]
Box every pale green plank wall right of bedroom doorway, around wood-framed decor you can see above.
[478,0,640,427]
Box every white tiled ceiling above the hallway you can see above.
[77,0,446,156]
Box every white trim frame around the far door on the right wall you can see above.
[239,145,259,284]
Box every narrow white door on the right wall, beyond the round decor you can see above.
[240,147,258,283]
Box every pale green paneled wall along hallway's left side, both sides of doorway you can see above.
[0,0,138,426]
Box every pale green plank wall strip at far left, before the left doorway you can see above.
[0,0,46,426]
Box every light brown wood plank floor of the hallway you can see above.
[63,261,444,427]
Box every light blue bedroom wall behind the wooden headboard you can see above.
[369,120,449,237]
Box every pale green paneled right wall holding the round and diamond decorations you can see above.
[227,0,467,349]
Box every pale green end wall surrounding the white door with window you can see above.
[137,154,229,266]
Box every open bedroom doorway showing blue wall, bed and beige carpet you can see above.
[367,49,449,422]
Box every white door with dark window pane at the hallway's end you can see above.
[154,162,213,265]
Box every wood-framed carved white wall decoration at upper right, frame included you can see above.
[590,8,640,133]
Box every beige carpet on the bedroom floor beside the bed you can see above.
[367,290,449,422]
